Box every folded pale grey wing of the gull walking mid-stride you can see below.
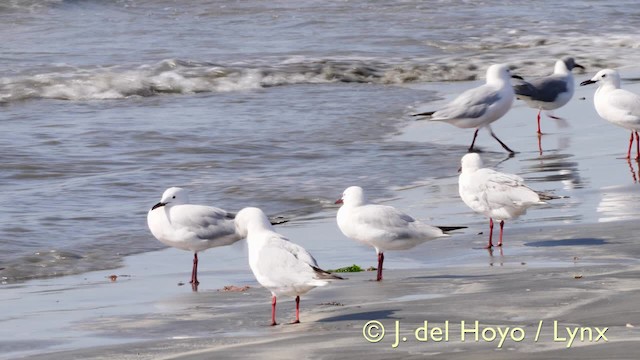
[432,85,501,120]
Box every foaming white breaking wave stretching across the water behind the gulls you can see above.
[0,35,640,103]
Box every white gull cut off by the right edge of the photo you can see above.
[580,69,640,160]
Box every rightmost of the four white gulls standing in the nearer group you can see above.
[458,153,551,249]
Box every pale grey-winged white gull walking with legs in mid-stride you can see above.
[413,64,522,154]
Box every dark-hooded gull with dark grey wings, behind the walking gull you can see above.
[513,57,584,135]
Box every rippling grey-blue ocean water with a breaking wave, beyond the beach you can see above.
[0,0,640,283]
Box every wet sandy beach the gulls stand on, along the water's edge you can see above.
[0,69,640,360]
